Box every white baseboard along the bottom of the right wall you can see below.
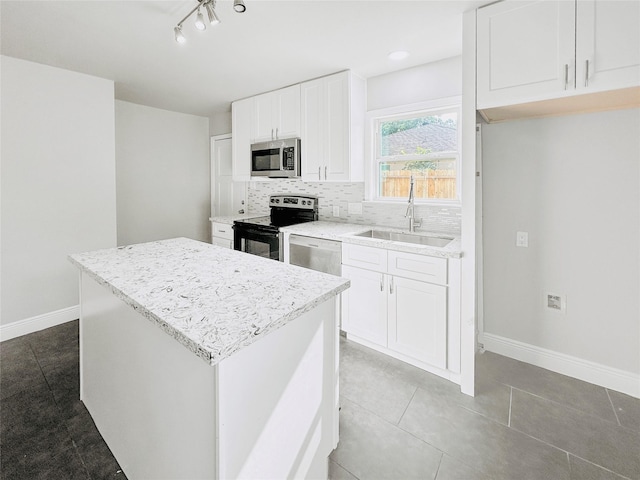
[478,333,640,398]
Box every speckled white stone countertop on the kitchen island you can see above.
[69,238,349,365]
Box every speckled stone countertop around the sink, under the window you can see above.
[280,221,462,258]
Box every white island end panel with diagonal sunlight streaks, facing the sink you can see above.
[218,298,338,479]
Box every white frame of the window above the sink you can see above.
[365,96,462,206]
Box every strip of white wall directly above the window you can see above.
[367,57,462,111]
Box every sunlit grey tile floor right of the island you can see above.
[330,339,640,480]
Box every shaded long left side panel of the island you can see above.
[80,273,217,480]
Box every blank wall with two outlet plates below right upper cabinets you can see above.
[483,109,640,378]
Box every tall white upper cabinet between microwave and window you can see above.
[300,71,365,182]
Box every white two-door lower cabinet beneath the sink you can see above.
[342,243,448,373]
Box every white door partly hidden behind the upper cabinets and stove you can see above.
[211,135,247,217]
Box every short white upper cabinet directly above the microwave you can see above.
[253,85,300,142]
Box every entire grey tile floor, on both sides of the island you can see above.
[0,321,640,480]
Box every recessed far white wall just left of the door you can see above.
[115,100,210,245]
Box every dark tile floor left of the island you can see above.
[0,321,126,480]
